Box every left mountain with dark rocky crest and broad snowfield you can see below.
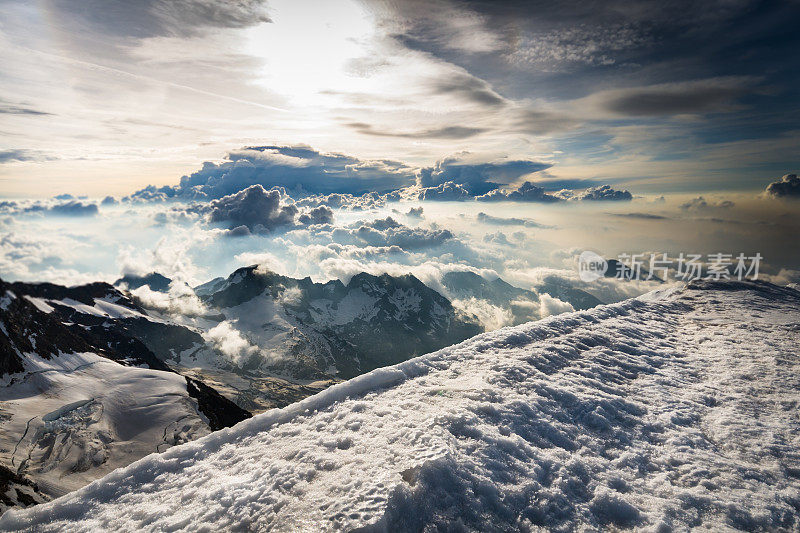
[0,280,250,506]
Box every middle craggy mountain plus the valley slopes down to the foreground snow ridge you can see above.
[150,266,483,412]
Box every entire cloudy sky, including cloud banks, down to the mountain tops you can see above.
[0,0,800,301]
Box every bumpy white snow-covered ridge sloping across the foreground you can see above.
[0,282,800,531]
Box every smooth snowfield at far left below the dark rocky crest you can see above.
[0,353,210,496]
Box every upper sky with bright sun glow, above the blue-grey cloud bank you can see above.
[0,0,800,197]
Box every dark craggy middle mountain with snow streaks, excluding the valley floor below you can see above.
[177,266,482,401]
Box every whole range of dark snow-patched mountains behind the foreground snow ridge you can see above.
[0,266,600,506]
